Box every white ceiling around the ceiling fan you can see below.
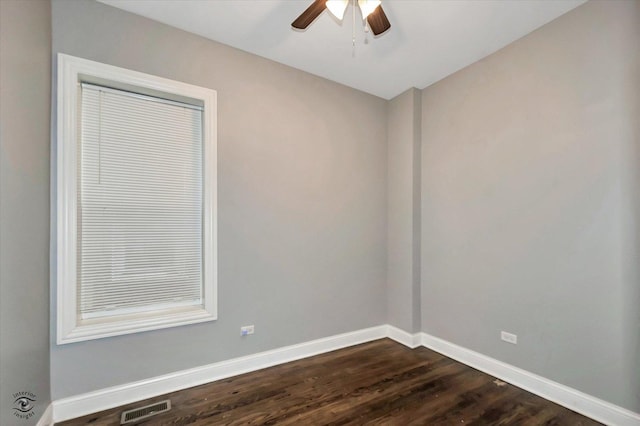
[100,0,586,99]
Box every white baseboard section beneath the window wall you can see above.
[53,325,388,422]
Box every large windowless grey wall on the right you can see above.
[422,1,640,412]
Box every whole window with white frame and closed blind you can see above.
[55,54,217,344]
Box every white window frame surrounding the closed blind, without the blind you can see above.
[52,54,218,344]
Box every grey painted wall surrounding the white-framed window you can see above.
[51,0,386,399]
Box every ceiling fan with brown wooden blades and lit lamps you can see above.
[291,0,391,35]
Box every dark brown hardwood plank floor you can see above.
[58,339,599,426]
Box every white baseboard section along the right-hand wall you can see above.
[418,333,640,426]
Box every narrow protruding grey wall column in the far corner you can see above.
[387,88,422,333]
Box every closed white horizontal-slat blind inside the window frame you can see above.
[76,84,203,320]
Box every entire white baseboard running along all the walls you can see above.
[50,325,640,426]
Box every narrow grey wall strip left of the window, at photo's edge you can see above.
[0,0,51,426]
